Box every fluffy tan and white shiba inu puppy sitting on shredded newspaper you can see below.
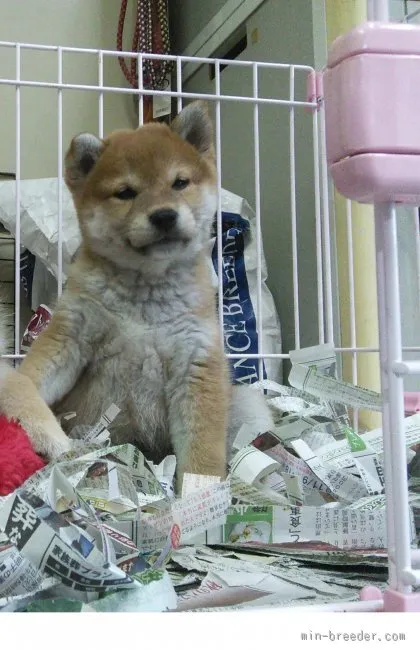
[0,102,271,480]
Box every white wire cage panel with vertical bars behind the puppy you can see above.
[0,42,334,376]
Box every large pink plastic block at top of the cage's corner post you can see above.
[324,23,420,205]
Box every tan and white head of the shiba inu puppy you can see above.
[65,102,217,275]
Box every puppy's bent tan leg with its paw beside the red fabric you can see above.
[0,309,85,459]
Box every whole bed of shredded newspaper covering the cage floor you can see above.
[0,345,420,612]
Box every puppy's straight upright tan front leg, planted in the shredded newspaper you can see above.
[168,349,230,489]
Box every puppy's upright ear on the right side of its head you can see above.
[171,101,214,154]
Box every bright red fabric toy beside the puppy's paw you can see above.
[0,415,45,496]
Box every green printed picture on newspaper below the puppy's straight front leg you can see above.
[223,506,273,544]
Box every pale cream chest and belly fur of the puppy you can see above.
[55,270,214,457]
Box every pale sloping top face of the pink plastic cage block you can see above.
[327,22,420,68]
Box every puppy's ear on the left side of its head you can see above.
[65,133,105,190]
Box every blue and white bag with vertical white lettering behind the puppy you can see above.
[210,190,282,384]
